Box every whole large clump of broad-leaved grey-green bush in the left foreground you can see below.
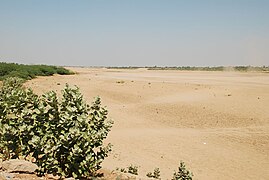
[0,78,113,178]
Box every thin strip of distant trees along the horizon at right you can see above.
[147,66,269,72]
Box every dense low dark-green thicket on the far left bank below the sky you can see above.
[0,62,74,80]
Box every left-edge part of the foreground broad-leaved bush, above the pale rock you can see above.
[0,78,39,160]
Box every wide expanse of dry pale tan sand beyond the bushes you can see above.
[27,68,269,180]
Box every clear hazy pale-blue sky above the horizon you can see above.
[0,0,269,66]
